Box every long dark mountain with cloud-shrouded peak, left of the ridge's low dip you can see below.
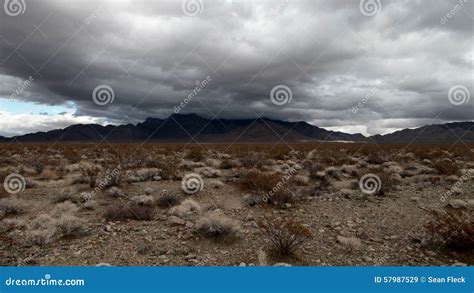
[0,114,366,143]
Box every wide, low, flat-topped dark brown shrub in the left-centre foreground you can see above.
[104,202,156,221]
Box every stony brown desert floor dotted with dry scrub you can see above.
[0,144,474,266]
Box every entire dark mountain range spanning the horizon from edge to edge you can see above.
[0,114,474,143]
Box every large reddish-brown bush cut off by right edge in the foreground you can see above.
[425,206,474,251]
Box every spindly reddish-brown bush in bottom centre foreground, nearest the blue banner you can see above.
[259,218,312,257]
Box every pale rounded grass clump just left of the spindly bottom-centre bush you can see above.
[195,211,240,238]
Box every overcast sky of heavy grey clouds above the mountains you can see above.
[0,0,474,136]
